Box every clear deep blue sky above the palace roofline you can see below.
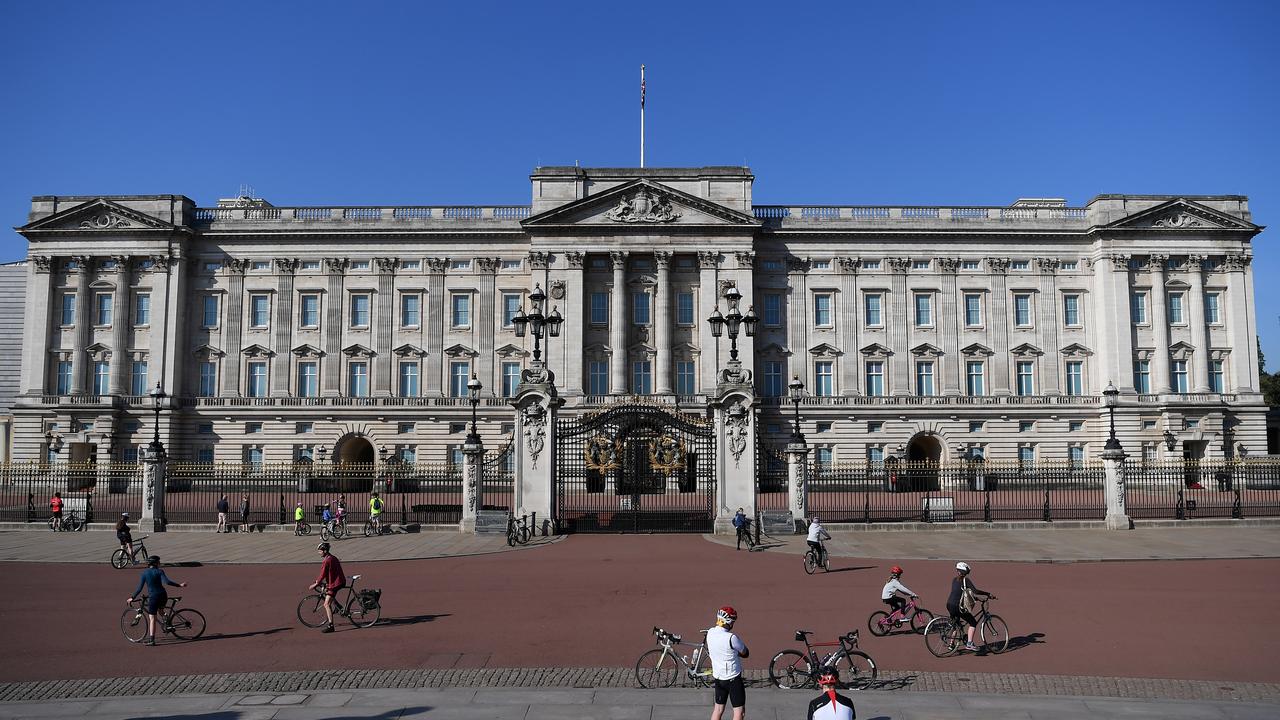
[0,0,1280,369]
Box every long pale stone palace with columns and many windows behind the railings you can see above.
[12,167,1266,527]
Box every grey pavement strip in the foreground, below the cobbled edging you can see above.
[0,688,1280,720]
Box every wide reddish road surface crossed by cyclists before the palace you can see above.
[0,536,1280,683]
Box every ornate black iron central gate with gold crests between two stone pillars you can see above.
[554,404,716,533]
